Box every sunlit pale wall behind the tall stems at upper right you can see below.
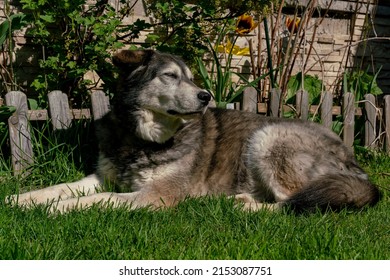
[229,0,378,91]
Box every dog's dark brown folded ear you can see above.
[112,50,155,70]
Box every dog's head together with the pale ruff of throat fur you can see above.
[113,50,211,143]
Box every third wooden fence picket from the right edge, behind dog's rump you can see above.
[343,92,355,147]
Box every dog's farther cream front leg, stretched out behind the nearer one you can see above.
[7,174,102,206]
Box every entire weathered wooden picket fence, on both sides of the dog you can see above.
[5,88,390,174]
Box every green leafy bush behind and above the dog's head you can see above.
[16,0,279,107]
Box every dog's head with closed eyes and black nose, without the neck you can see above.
[113,50,211,118]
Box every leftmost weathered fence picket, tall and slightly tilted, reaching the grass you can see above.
[5,91,34,175]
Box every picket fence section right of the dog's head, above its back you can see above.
[243,89,390,153]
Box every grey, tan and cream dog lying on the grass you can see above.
[13,50,380,212]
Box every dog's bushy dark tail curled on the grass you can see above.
[285,174,381,213]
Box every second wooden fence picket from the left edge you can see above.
[48,90,72,129]
